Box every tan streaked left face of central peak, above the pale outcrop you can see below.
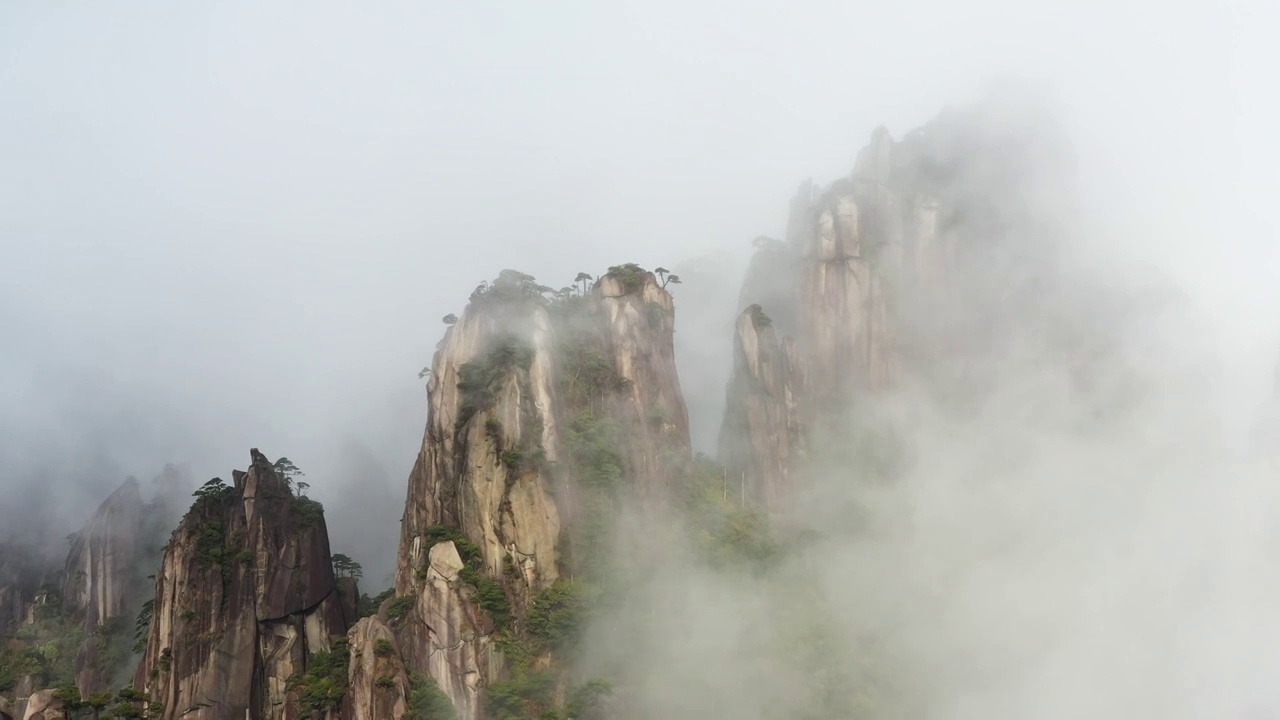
[396,271,559,593]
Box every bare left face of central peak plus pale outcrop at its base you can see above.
[396,272,561,720]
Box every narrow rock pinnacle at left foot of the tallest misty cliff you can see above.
[719,305,804,511]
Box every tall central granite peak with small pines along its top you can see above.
[386,265,690,720]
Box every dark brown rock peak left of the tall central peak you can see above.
[134,450,353,720]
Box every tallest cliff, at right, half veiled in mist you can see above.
[719,99,1064,506]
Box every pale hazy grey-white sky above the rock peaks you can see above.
[0,0,1280,573]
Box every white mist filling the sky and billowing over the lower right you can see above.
[0,0,1280,719]
